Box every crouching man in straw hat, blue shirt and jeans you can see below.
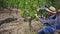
[36,6,56,34]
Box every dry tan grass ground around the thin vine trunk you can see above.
[0,19,42,34]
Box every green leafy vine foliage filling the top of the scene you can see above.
[0,0,60,18]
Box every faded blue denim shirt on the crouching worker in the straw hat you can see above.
[38,15,56,30]
